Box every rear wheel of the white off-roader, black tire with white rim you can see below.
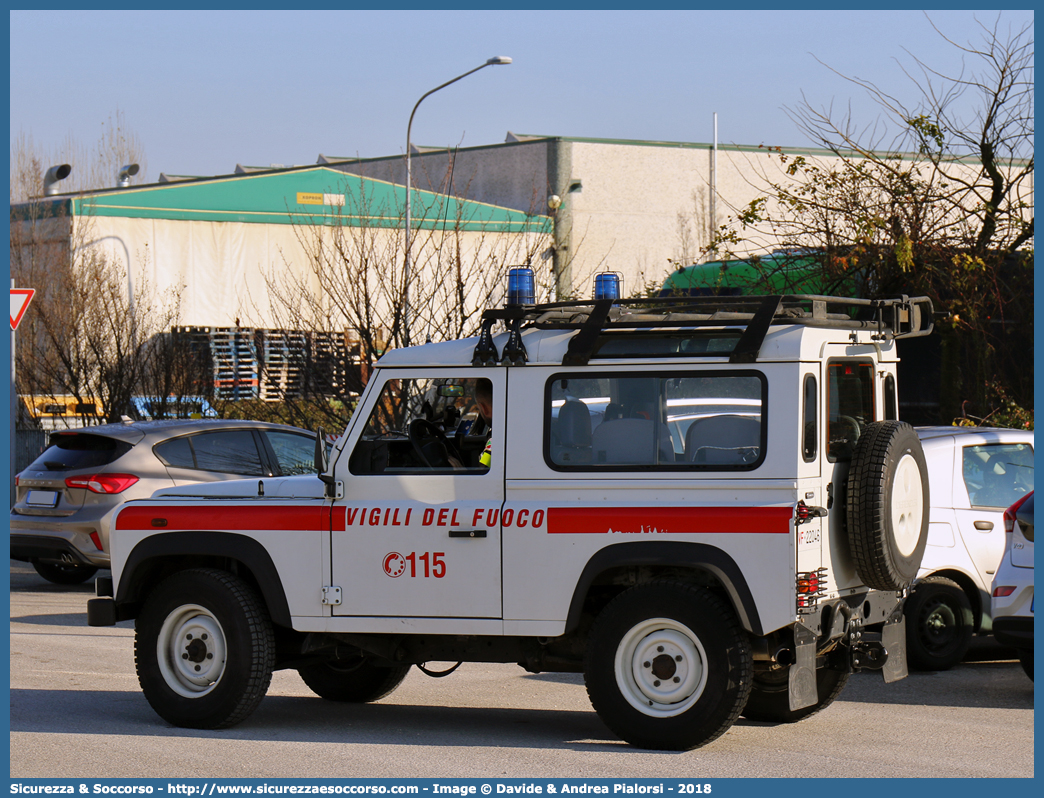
[584,582,753,751]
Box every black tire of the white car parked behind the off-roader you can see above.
[903,577,975,671]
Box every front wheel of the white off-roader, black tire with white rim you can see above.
[135,568,276,729]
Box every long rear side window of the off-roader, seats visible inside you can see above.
[544,372,765,471]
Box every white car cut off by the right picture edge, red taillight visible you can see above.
[991,493,1034,679]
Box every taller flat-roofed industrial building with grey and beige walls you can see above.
[319,133,1033,295]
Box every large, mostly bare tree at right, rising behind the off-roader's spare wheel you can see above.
[708,16,1034,418]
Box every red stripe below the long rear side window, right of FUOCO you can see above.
[547,507,793,535]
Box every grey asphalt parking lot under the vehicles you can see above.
[10,562,1034,779]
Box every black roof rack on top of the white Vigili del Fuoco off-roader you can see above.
[472,294,933,366]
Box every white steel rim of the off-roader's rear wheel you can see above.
[614,618,707,718]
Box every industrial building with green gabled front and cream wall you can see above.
[11,161,551,417]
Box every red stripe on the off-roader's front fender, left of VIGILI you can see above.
[116,504,334,532]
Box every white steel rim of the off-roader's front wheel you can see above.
[156,604,228,698]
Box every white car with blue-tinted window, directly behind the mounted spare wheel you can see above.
[904,426,1034,671]
